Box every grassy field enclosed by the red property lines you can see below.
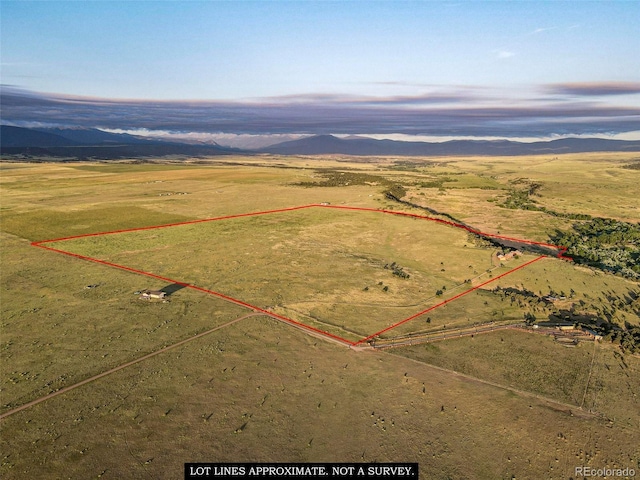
[47,207,518,340]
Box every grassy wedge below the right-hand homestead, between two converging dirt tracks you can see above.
[393,330,640,428]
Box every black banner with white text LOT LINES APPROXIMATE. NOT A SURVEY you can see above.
[184,463,418,480]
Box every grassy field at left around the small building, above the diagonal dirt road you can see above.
[0,234,246,413]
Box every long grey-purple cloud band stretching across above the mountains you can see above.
[0,83,640,137]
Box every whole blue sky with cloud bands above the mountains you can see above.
[0,0,640,144]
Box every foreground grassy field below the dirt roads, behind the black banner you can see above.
[2,318,640,479]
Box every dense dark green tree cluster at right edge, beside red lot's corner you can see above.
[551,218,640,279]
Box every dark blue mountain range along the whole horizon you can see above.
[0,125,640,159]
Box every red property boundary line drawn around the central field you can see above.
[31,203,572,347]
